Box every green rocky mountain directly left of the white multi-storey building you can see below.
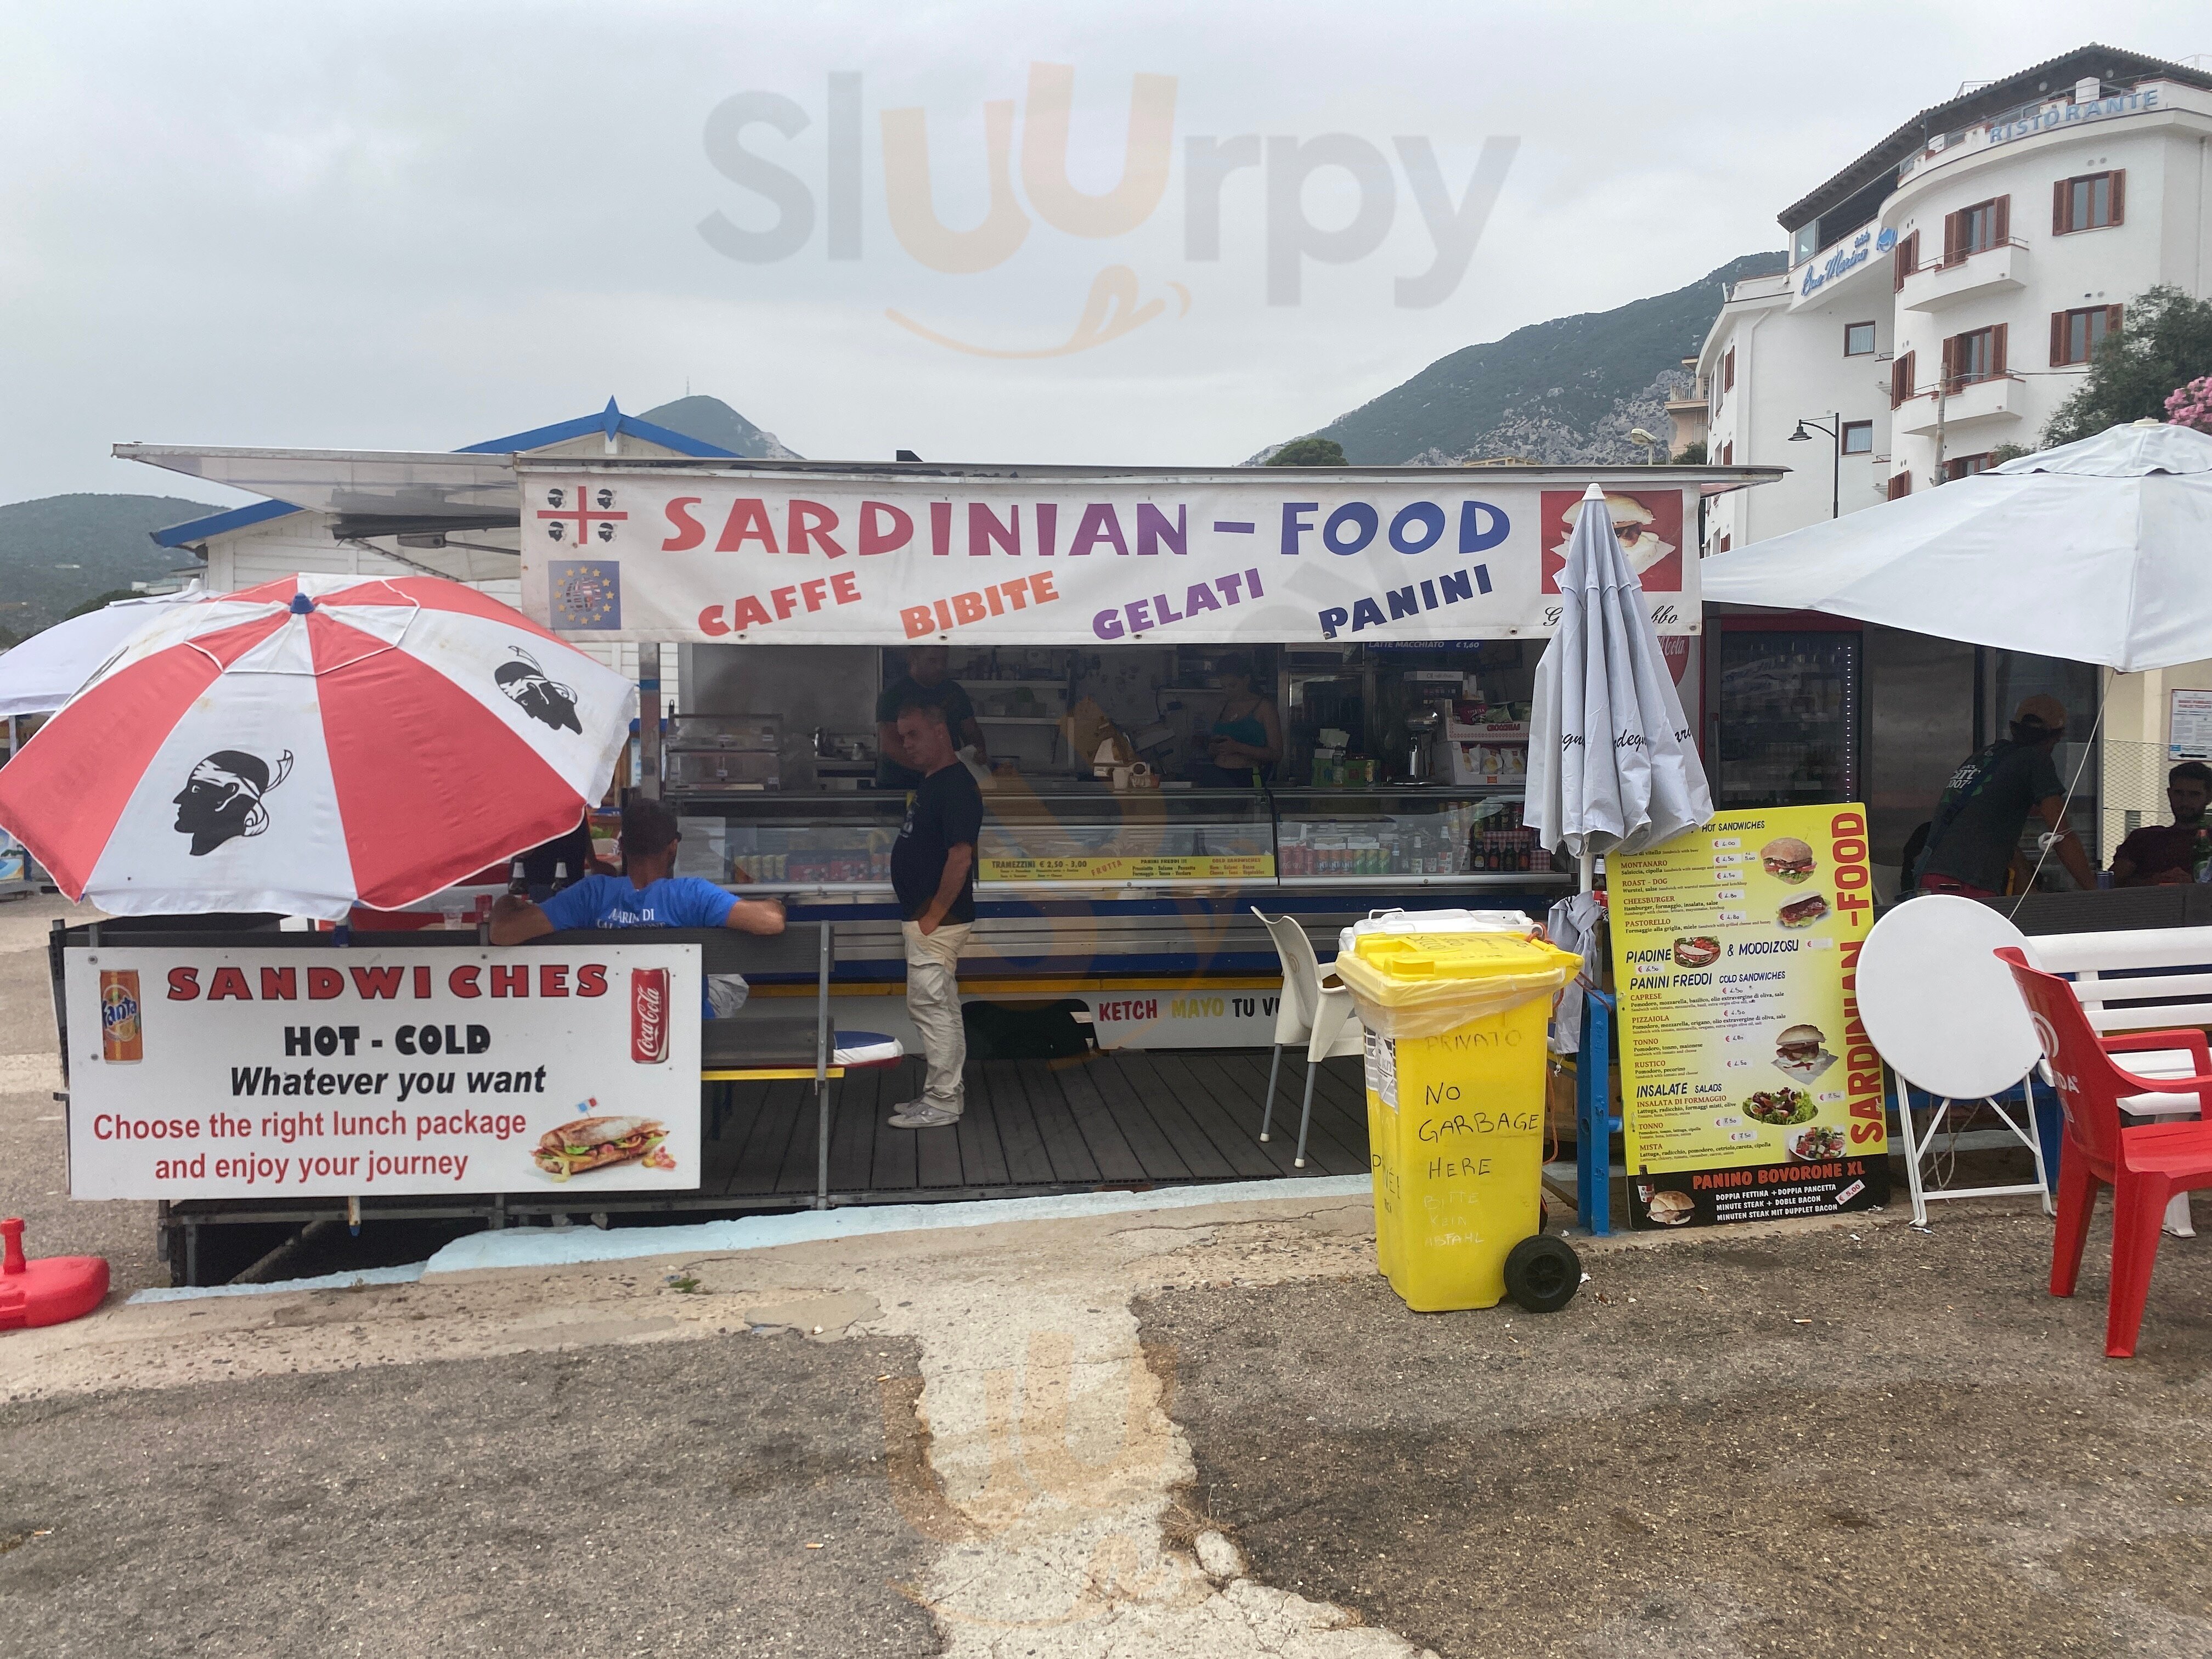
[1252,252,1785,467]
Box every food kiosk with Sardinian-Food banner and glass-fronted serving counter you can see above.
[515,458,1763,1048]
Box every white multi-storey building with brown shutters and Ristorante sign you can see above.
[1697,47,2212,551]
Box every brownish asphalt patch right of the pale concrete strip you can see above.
[1139,1210,2212,1659]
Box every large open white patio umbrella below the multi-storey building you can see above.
[1699,420,2212,673]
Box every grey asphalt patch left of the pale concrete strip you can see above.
[0,1331,938,1659]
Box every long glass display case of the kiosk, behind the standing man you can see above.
[677,778,1550,896]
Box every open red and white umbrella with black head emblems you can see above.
[0,575,630,920]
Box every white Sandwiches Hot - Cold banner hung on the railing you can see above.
[62,934,699,1203]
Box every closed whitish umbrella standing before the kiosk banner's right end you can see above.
[1526,484,1712,887]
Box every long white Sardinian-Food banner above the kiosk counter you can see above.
[517,473,1699,646]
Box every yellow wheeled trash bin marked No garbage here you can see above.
[1336,934,1582,1314]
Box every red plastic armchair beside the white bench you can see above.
[1997,945,2212,1358]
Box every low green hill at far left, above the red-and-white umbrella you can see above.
[0,495,217,639]
